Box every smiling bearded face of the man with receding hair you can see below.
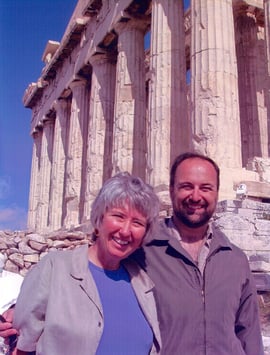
[170,158,218,228]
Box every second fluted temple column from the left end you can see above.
[36,117,54,232]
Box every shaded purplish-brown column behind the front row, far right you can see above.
[235,8,269,166]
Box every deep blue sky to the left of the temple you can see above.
[0,0,77,230]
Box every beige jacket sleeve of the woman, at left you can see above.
[13,256,52,352]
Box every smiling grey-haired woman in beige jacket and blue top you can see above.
[14,173,161,355]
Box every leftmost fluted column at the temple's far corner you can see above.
[27,130,42,230]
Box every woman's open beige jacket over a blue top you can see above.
[14,245,161,355]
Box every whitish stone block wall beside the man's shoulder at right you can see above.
[215,199,270,291]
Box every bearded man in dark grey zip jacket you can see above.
[133,153,263,355]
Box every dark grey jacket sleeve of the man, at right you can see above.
[235,261,264,355]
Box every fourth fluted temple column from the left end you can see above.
[63,80,89,228]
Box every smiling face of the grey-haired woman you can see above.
[93,204,147,269]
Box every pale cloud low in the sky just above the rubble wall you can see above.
[0,205,27,231]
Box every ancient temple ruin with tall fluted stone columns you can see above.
[23,0,270,232]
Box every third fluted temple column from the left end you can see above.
[49,99,70,230]
